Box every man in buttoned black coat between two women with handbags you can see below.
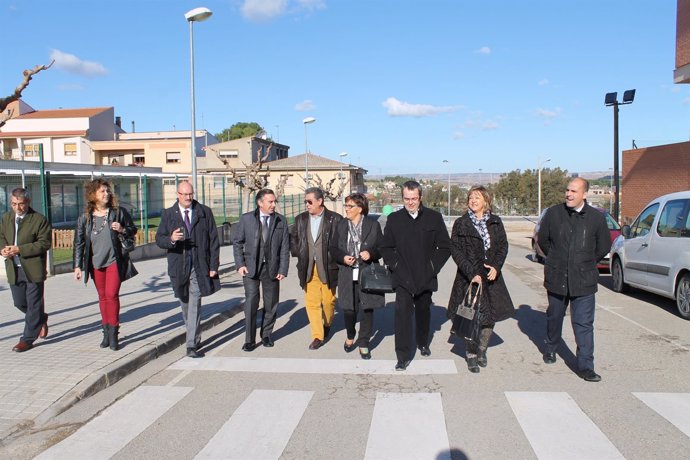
[380,181,450,371]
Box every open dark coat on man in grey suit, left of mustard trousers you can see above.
[232,208,290,278]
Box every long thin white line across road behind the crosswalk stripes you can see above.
[170,357,458,375]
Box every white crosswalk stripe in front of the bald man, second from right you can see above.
[505,391,624,460]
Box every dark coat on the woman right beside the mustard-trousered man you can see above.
[330,216,386,311]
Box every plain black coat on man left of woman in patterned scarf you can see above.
[380,206,450,295]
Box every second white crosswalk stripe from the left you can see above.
[194,390,314,460]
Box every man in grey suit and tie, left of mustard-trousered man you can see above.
[232,189,290,351]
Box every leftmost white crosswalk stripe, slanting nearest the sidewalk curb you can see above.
[36,386,193,460]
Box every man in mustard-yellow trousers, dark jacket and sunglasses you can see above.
[290,187,342,350]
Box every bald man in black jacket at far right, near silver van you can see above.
[538,177,611,382]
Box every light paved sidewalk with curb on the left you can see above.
[0,246,244,443]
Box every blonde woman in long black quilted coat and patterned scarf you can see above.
[448,186,515,373]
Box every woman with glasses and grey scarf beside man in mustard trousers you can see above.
[330,193,385,359]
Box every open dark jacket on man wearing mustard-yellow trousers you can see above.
[290,209,343,289]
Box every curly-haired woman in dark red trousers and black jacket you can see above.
[73,178,137,350]
